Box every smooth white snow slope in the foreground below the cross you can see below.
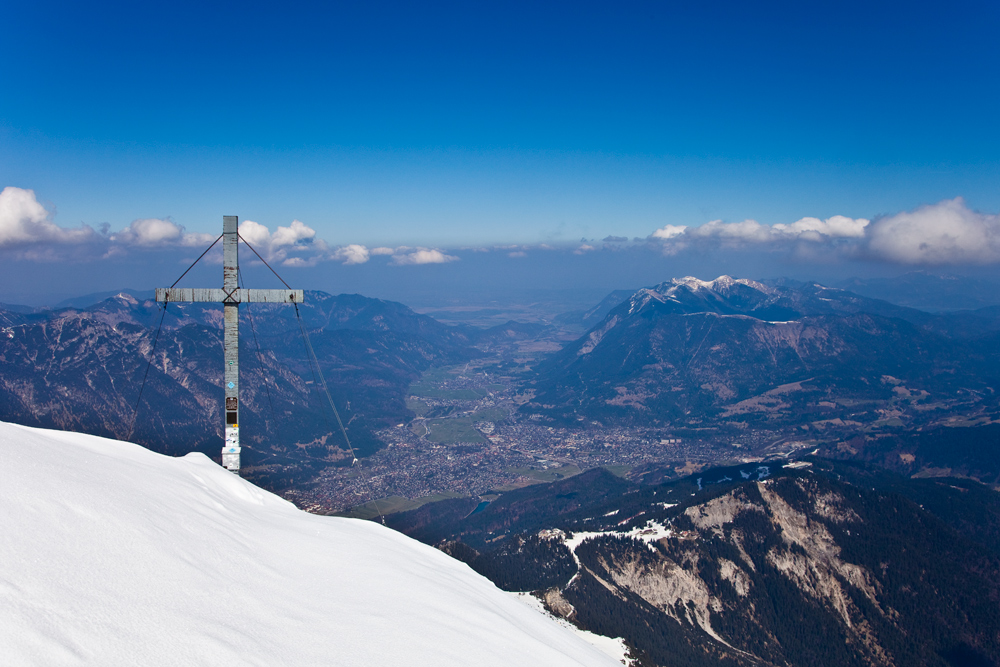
[0,422,618,667]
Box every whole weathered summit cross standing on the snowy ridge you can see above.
[156,215,304,473]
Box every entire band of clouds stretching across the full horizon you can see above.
[7,187,1000,266]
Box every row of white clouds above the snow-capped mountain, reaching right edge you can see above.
[648,197,1000,265]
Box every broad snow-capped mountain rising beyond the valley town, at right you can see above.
[523,276,998,425]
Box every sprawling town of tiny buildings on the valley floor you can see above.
[295,373,780,511]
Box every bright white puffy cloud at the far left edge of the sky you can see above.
[0,186,101,248]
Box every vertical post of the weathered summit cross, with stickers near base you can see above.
[222,215,240,472]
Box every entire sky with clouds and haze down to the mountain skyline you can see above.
[0,2,1000,304]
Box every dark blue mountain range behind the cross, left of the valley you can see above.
[0,292,478,483]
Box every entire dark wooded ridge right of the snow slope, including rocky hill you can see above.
[390,458,1000,666]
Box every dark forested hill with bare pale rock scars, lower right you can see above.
[550,477,1000,665]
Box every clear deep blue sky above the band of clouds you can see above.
[0,1,1000,296]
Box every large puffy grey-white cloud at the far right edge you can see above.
[868,197,1000,264]
